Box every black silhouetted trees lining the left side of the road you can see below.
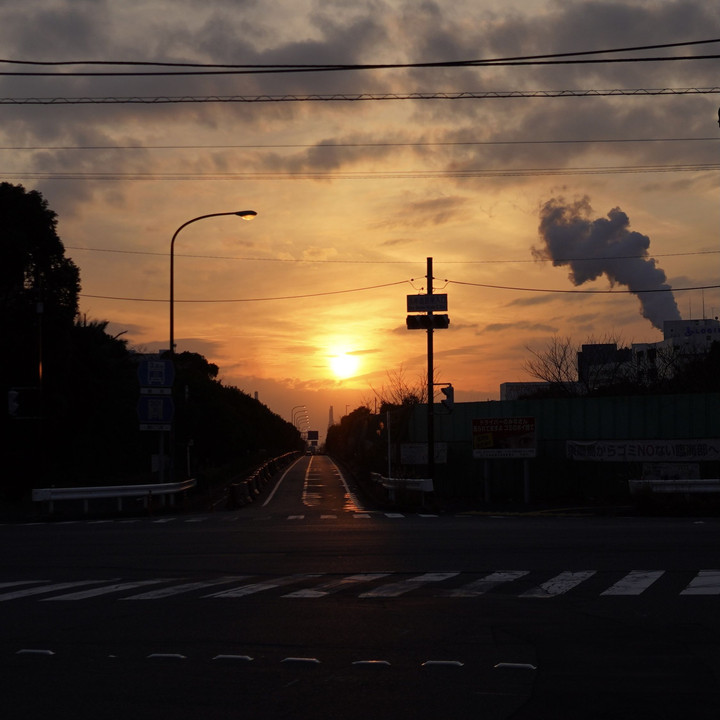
[0,183,303,496]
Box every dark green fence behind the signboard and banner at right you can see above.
[408,393,720,501]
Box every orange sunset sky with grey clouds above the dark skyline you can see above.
[0,0,720,436]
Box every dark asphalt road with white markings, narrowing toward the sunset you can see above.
[0,456,720,720]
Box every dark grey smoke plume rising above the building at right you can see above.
[532,197,681,330]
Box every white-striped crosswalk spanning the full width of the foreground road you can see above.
[0,570,720,604]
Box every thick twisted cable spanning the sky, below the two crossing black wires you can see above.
[0,87,720,105]
